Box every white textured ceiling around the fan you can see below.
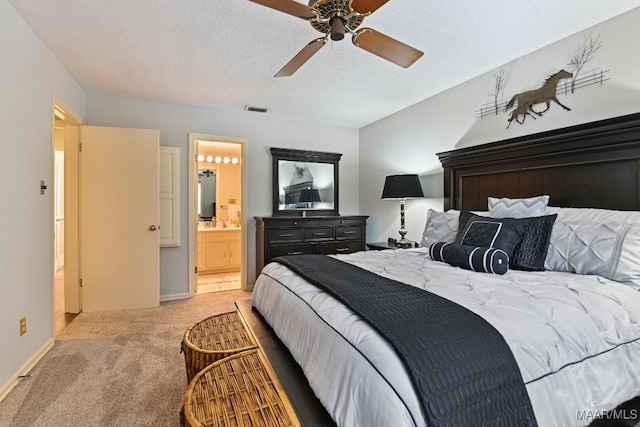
[9,0,638,128]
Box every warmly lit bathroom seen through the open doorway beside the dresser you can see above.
[190,134,246,294]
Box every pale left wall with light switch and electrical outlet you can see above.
[0,0,86,397]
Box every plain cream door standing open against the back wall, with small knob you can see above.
[80,126,160,311]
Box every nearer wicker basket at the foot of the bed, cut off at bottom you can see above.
[184,349,300,427]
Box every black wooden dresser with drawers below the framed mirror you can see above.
[255,215,369,273]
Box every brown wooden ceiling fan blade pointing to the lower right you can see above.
[351,28,423,68]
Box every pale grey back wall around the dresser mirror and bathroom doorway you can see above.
[87,93,359,296]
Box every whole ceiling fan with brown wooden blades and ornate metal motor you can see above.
[250,0,423,77]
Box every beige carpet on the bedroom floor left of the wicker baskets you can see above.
[0,291,251,427]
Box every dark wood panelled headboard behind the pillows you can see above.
[438,113,640,210]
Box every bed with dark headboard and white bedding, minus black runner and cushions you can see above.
[252,115,640,426]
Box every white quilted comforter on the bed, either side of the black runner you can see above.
[252,249,640,427]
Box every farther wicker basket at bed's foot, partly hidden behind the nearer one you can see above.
[182,311,258,382]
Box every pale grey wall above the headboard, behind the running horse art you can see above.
[360,8,640,241]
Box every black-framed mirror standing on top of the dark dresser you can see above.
[271,148,342,216]
